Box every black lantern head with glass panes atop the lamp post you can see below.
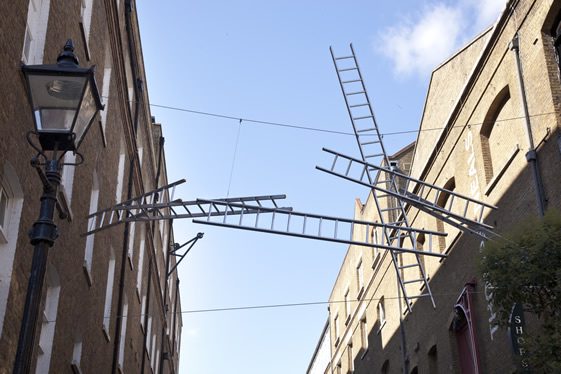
[22,40,103,151]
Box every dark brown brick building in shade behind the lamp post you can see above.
[0,0,181,373]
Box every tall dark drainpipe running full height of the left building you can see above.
[111,0,142,373]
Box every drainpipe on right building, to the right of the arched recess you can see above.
[510,34,546,216]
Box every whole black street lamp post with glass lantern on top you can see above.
[13,40,103,374]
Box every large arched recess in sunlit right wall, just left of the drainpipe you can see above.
[479,86,512,183]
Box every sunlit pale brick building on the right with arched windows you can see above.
[314,0,561,373]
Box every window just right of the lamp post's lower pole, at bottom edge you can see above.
[35,266,60,374]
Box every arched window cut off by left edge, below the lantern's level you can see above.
[0,162,23,336]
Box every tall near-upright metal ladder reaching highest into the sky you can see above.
[329,44,436,311]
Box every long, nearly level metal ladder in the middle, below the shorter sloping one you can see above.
[193,199,447,258]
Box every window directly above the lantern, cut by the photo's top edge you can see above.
[21,0,51,65]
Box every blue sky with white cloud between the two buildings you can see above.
[137,0,505,374]
